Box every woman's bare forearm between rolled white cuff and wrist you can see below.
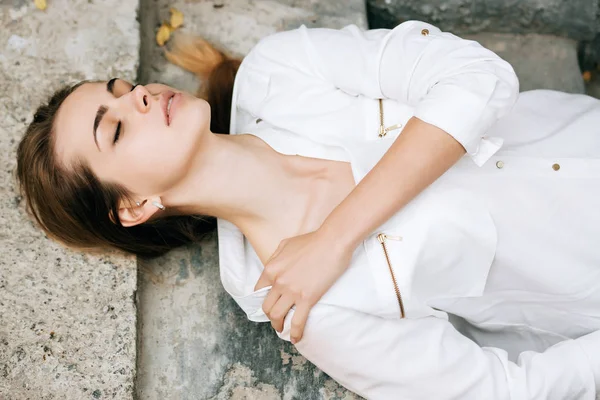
[319,117,465,249]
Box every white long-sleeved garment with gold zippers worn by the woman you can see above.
[217,21,600,400]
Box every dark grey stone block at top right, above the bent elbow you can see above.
[367,0,600,40]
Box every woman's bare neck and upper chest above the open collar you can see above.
[159,133,318,238]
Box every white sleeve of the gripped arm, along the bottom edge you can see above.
[279,304,600,400]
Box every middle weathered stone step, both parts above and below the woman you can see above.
[137,0,366,400]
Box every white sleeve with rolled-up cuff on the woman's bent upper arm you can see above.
[244,21,519,165]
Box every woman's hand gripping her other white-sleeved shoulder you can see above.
[254,230,354,344]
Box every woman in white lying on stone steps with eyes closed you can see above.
[18,21,600,400]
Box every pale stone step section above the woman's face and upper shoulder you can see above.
[138,0,367,86]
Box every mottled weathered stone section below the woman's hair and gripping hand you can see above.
[137,232,359,400]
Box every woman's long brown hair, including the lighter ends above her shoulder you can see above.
[17,35,240,257]
